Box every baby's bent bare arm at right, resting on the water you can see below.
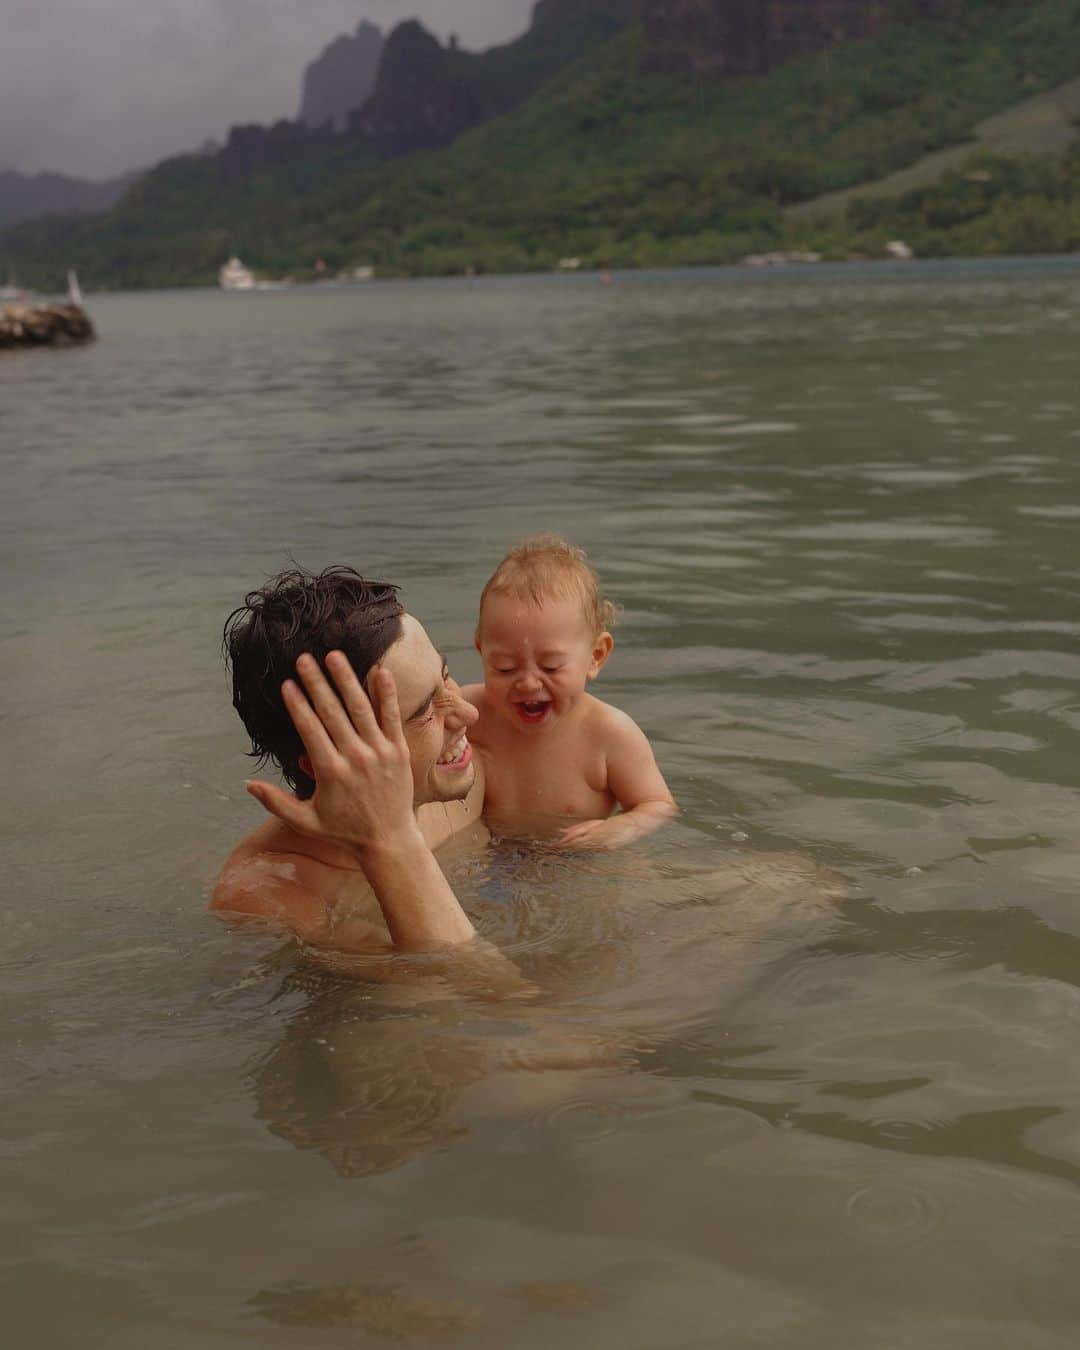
[559,706,679,848]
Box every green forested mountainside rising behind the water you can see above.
[0,0,1080,286]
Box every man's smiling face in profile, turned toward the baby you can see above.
[379,614,479,806]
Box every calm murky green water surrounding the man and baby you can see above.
[0,261,1080,1350]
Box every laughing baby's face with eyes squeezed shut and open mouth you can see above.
[477,595,612,734]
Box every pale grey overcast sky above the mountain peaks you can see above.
[0,0,533,178]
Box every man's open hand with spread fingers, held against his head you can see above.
[247,652,419,853]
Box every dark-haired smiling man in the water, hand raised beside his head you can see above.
[211,567,483,952]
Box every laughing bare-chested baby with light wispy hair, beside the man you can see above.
[463,535,678,848]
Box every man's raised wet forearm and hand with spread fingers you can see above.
[247,652,475,950]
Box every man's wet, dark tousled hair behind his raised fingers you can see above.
[223,567,405,798]
